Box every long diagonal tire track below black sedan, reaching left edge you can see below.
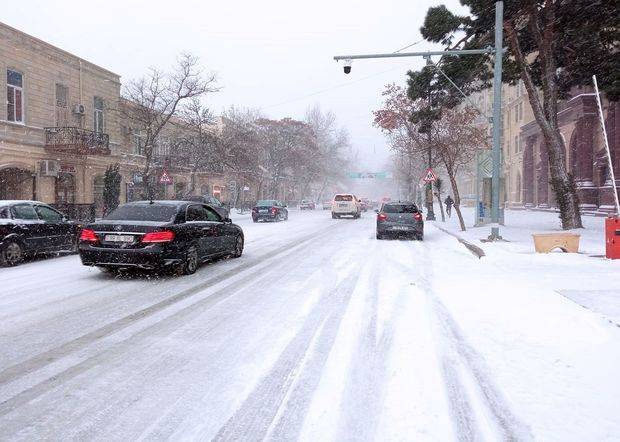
[0,223,343,386]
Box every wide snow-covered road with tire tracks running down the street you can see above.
[0,210,620,441]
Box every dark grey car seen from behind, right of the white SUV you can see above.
[377,201,424,241]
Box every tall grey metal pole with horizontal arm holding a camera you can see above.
[334,1,504,241]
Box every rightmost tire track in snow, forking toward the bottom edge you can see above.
[412,230,533,441]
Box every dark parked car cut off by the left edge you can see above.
[0,200,80,266]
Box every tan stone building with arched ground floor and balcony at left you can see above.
[0,23,229,218]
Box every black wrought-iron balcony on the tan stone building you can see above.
[45,127,110,155]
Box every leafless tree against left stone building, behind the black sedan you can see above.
[119,54,218,198]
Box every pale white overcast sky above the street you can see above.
[0,0,462,170]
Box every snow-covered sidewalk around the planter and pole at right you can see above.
[435,207,620,324]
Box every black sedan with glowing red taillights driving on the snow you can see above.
[79,201,244,275]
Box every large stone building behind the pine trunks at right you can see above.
[464,81,620,216]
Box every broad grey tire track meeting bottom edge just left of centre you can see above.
[213,265,361,441]
